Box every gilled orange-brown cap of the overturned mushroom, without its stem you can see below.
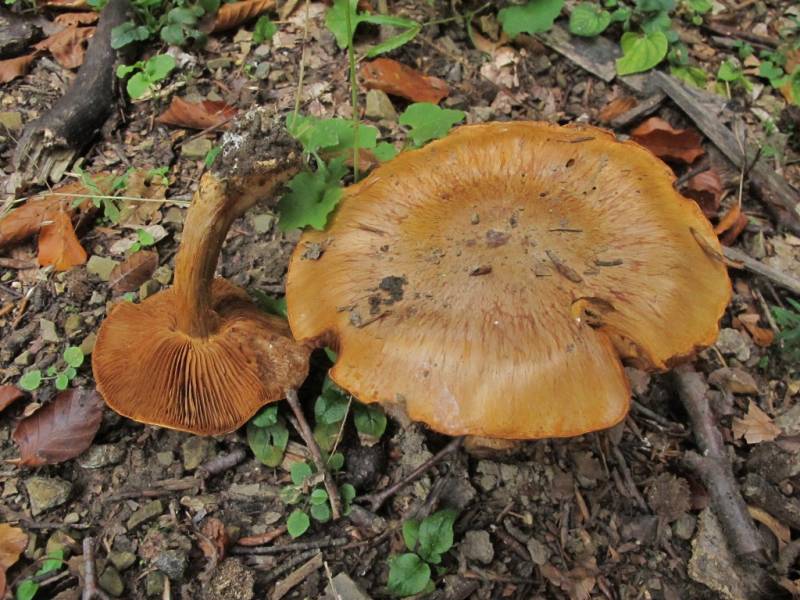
[92,279,308,435]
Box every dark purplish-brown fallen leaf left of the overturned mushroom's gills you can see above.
[13,388,103,467]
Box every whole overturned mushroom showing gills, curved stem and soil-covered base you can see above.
[92,111,310,435]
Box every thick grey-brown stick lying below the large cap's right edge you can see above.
[673,367,764,562]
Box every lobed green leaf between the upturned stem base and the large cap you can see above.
[278,158,347,231]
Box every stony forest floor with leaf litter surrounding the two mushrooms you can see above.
[0,0,800,600]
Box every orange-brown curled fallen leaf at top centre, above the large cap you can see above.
[359,58,450,104]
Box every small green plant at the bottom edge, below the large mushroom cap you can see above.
[387,509,458,597]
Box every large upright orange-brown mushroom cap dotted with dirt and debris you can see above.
[287,122,730,439]
